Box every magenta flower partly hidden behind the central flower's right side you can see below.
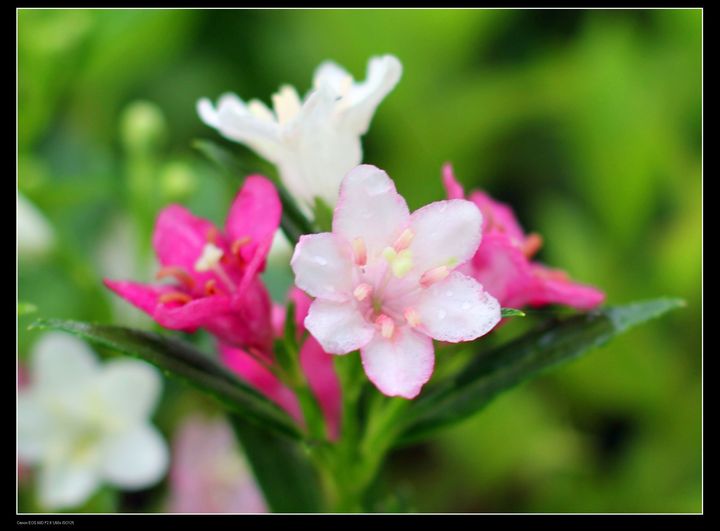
[443,164,605,309]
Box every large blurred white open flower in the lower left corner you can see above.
[18,332,168,509]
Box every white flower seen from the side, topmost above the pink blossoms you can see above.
[197,55,402,210]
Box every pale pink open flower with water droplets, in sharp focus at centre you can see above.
[291,165,500,398]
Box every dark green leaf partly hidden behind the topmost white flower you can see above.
[193,140,315,246]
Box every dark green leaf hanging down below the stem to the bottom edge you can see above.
[231,416,322,513]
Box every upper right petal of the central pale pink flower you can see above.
[410,199,482,274]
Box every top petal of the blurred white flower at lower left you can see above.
[31,332,99,393]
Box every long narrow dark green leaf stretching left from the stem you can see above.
[31,319,300,438]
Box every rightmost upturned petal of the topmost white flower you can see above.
[343,55,402,135]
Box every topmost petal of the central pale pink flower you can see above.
[333,164,410,257]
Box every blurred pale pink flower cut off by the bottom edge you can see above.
[168,416,267,513]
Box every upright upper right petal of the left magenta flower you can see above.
[225,175,282,270]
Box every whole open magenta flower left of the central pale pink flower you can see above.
[105,175,281,353]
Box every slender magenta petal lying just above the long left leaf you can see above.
[219,343,302,420]
